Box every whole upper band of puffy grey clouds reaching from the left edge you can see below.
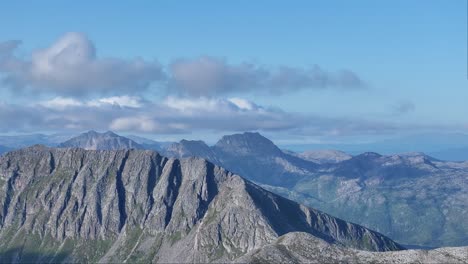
[0,32,365,97]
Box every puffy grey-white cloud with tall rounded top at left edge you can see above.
[0,32,164,95]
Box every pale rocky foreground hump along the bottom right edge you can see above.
[235,232,468,264]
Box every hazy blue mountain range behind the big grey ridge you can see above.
[0,132,468,247]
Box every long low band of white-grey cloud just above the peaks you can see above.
[0,96,428,136]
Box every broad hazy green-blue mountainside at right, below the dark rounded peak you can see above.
[270,153,468,247]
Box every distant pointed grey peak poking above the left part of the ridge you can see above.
[58,131,144,150]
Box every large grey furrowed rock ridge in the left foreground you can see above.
[0,146,402,262]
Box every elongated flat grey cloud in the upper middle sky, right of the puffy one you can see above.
[169,56,365,96]
